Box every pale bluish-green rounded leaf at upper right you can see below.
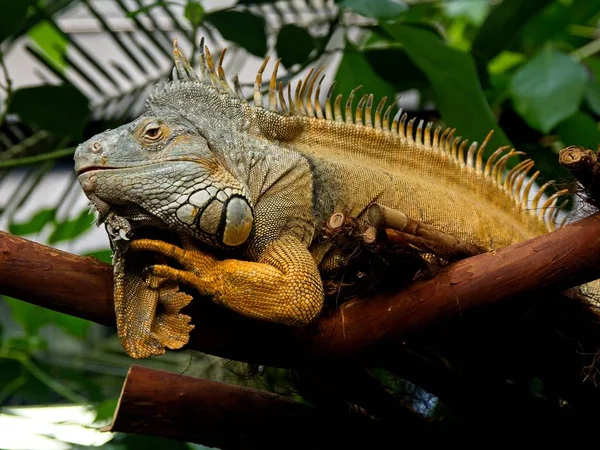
[510,49,588,133]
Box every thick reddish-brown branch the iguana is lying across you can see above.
[0,215,600,367]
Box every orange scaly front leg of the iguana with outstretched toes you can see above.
[129,236,324,325]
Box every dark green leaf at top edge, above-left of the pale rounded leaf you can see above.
[471,0,553,60]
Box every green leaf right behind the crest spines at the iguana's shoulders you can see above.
[335,46,396,111]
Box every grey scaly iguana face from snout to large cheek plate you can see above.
[75,113,253,247]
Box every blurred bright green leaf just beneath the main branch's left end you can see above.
[3,296,91,339]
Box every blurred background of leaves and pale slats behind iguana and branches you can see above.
[0,0,600,449]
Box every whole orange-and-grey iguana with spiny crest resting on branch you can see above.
[75,41,592,358]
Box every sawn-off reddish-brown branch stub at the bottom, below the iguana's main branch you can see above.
[105,366,396,449]
